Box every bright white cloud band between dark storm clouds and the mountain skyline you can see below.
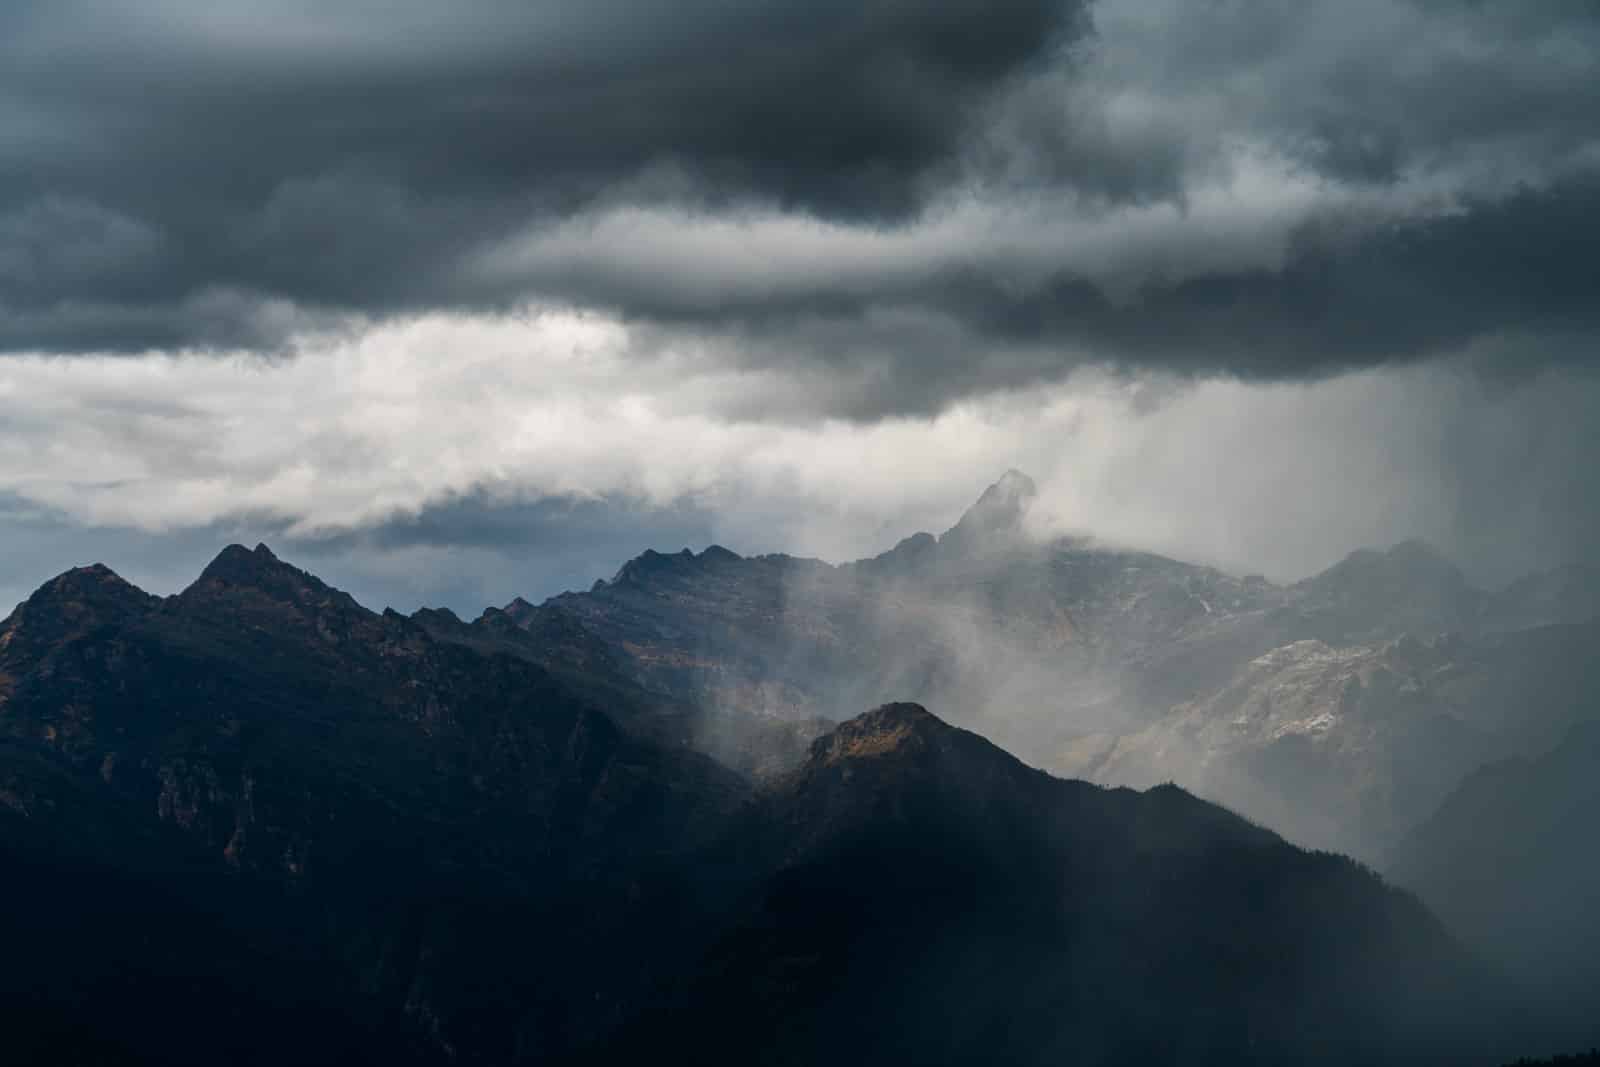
[0,314,1600,611]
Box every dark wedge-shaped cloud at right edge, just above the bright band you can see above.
[928,176,1600,378]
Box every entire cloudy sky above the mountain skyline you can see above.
[0,0,1600,614]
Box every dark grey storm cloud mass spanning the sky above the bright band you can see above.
[0,0,1600,418]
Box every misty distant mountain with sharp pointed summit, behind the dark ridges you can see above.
[502,472,1600,862]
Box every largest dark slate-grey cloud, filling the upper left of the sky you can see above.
[0,0,1080,349]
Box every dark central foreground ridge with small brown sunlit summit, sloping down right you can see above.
[603,704,1507,1064]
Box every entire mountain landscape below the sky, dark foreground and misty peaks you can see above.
[0,472,1597,1064]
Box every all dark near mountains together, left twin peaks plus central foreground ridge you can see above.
[0,547,1512,1064]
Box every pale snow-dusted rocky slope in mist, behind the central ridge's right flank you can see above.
[1053,622,1600,862]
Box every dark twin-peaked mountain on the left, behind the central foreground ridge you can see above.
[0,547,746,1062]
